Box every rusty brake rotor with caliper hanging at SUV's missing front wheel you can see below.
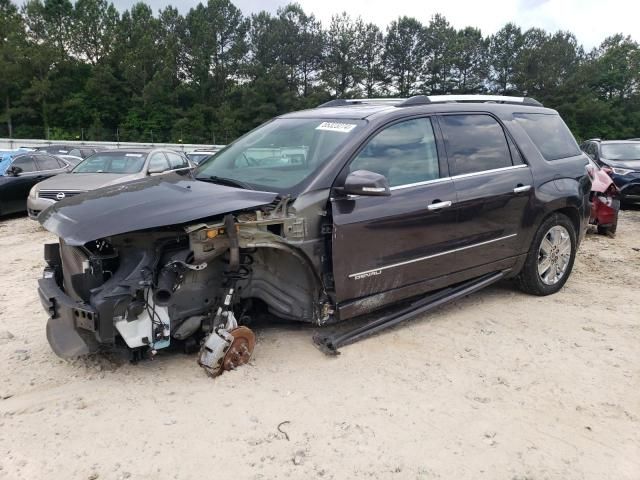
[198,327,256,377]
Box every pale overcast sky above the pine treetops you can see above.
[114,0,640,49]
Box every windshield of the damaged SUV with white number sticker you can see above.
[196,118,365,191]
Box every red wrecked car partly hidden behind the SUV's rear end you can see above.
[587,161,620,235]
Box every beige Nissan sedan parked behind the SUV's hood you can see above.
[27,148,193,220]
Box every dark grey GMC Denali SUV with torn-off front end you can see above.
[39,96,591,375]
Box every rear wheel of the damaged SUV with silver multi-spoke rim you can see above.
[517,213,576,296]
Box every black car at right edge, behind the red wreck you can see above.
[580,138,640,203]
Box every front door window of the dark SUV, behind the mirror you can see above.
[349,118,440,187]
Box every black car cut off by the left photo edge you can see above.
[0,152,70,216]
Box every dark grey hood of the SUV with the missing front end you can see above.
[38,174,278,245]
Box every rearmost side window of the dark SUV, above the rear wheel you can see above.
[513,113,580,161]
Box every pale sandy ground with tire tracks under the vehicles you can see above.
[0,211,640,480]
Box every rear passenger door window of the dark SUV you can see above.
[440,115,513,175]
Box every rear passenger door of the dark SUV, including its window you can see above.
[438,113,534,269]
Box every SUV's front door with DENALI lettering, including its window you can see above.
[332,117,458,302]
